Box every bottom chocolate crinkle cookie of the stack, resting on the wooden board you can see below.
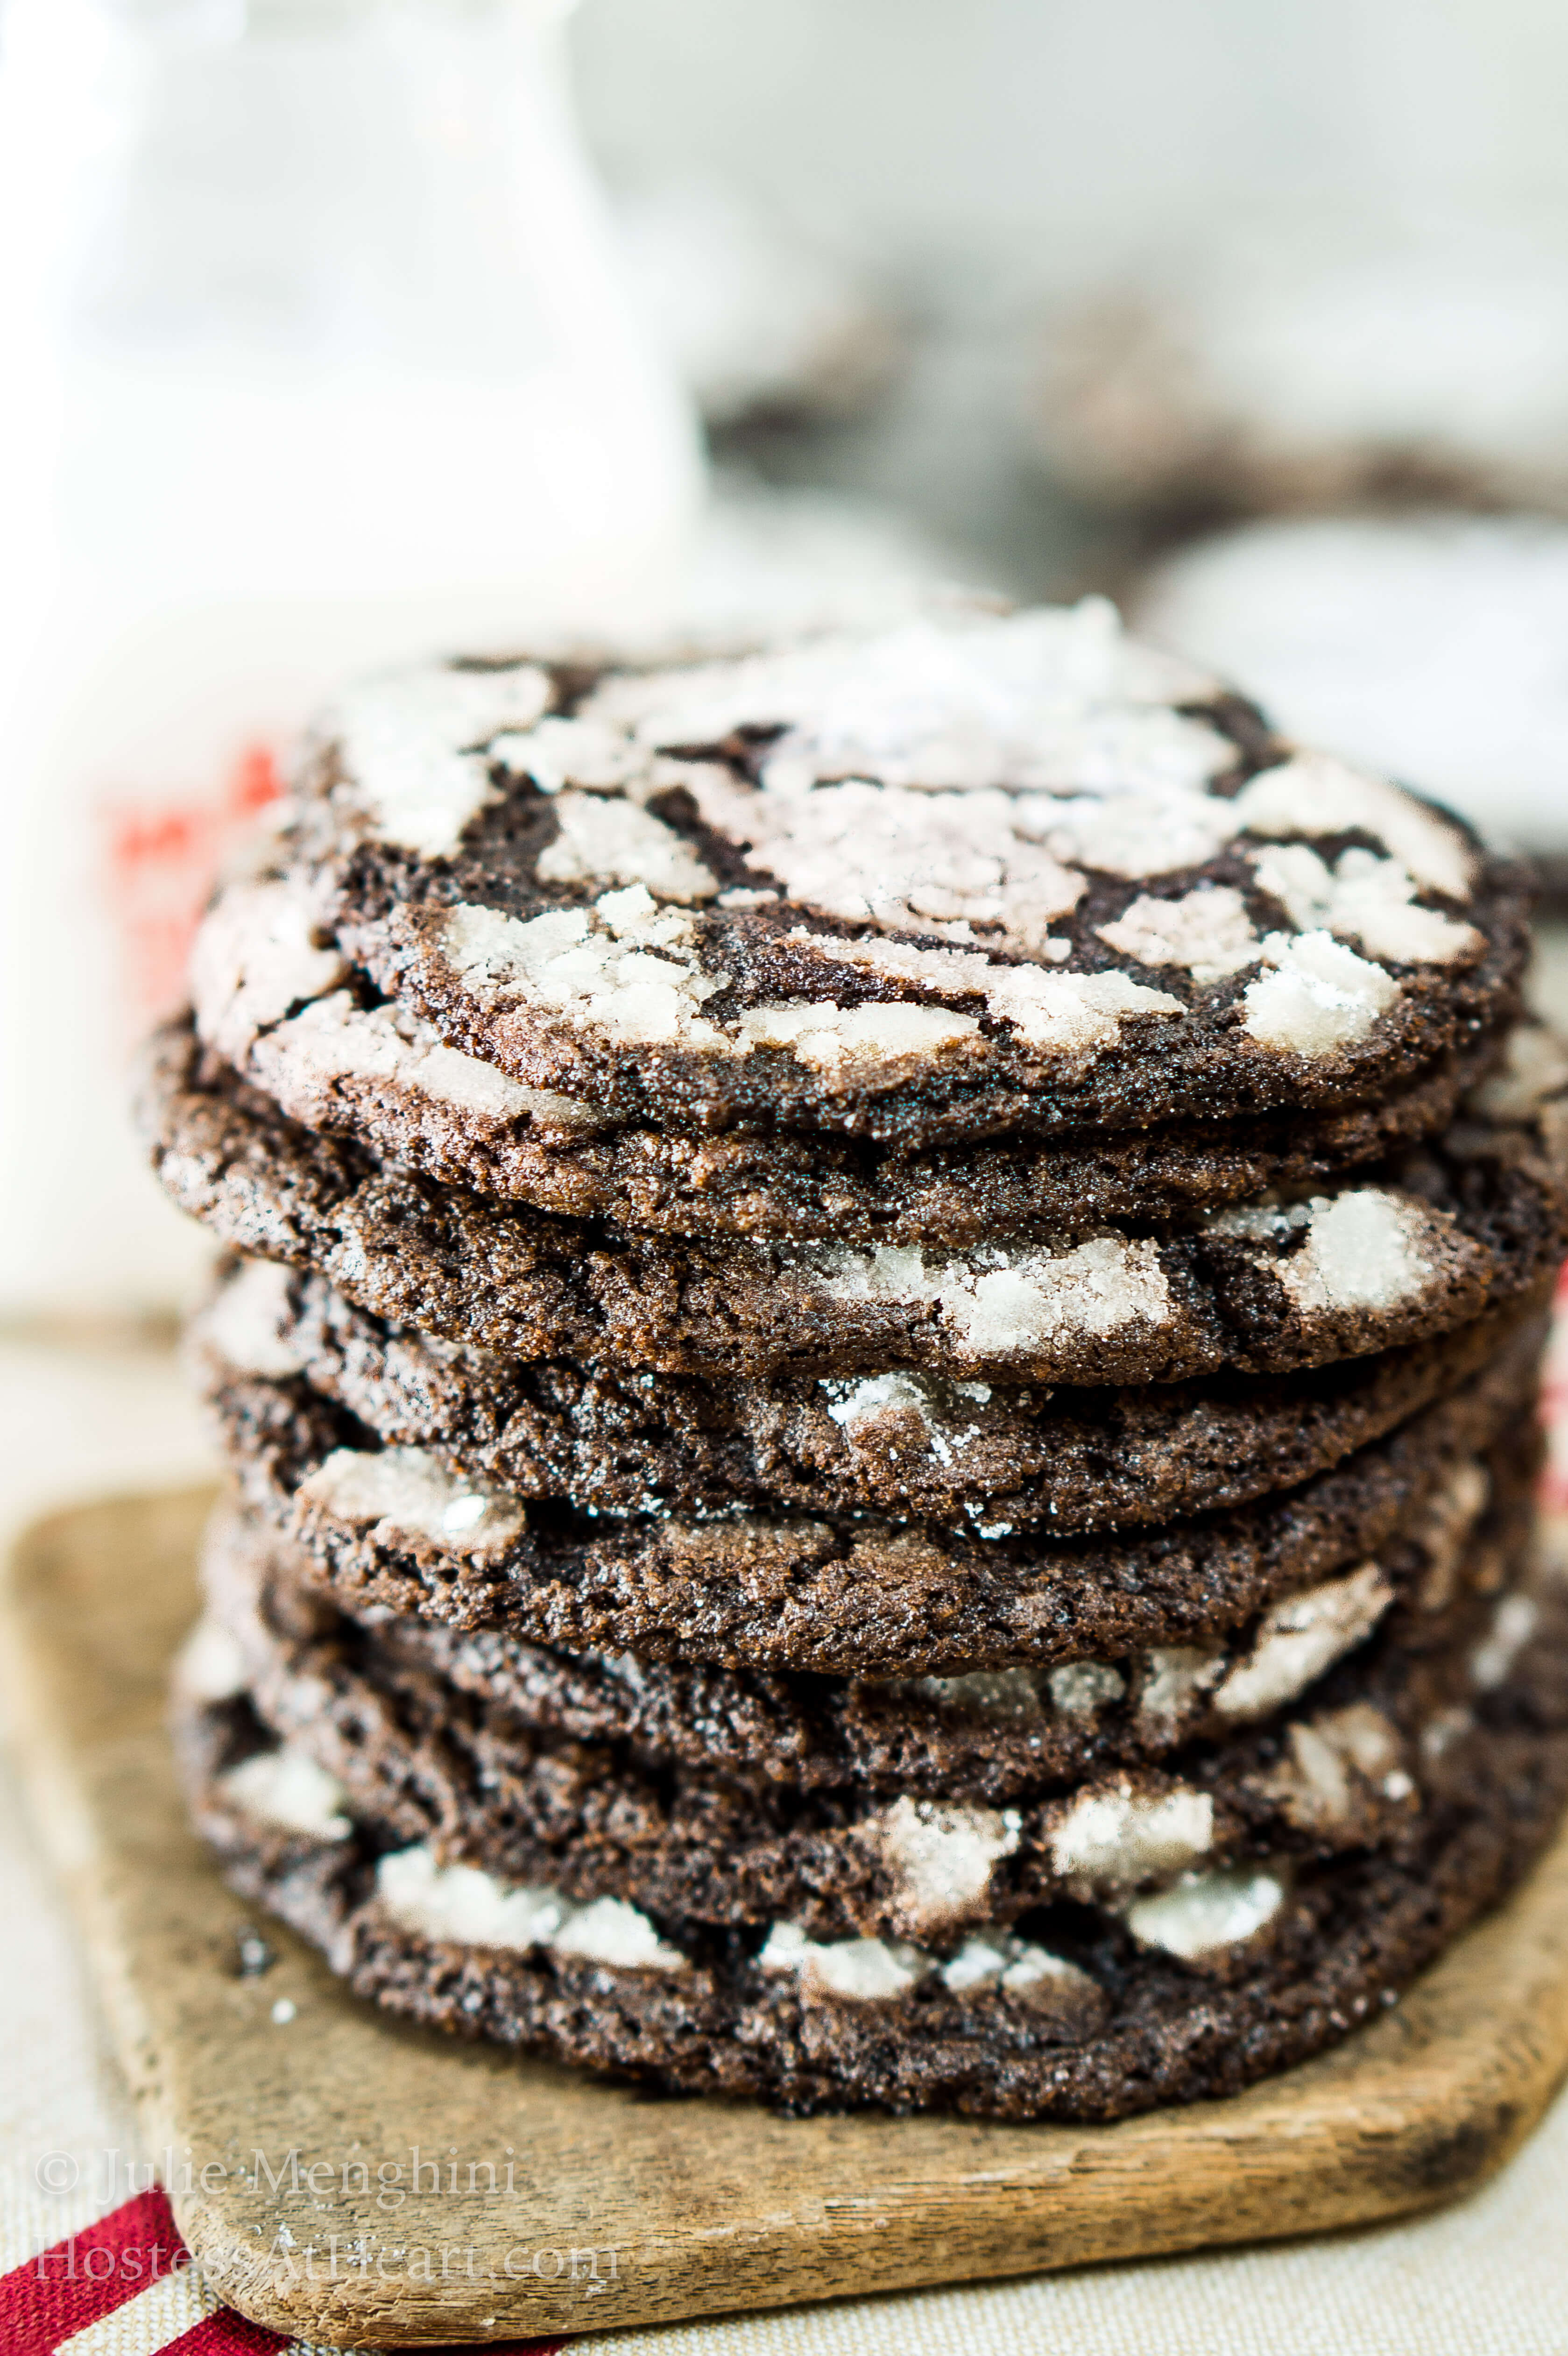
[170,1583,1568,2121]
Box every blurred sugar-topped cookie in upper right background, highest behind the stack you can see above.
[1029,205,1568,525]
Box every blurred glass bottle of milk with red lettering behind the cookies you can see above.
[0,0,699,1317]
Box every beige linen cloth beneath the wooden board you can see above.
[0,1310,1568,2356]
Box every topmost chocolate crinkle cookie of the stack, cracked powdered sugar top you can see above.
[195,601,1523,1145]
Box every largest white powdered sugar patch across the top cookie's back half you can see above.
[323,598,1234,952]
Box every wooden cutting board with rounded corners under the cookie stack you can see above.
[0,1491,1568,2347]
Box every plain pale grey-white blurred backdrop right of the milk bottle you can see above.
[572,0,1568,302]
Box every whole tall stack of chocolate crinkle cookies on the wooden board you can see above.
[146,601,1568,2118]
